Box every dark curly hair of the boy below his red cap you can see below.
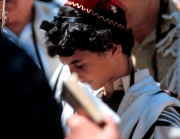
[43,6,134,57]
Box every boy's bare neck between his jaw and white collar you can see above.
[104,55,131,98]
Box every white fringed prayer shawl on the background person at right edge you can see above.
[155,12,180,95]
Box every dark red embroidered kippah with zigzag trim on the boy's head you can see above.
[64,0,126,29]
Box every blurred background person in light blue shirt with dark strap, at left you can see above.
[5,0,59,80]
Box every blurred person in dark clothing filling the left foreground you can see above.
[0,0,64,139]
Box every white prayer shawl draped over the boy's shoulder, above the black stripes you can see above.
[117,76,180,139]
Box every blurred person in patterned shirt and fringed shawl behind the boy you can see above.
[116,0,180,99]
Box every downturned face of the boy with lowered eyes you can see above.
[60,50,114,90]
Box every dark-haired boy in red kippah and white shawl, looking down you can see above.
[41,0,180,139]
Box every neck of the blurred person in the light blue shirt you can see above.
[6,10,32,37]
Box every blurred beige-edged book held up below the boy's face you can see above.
[61,73,120,126]
